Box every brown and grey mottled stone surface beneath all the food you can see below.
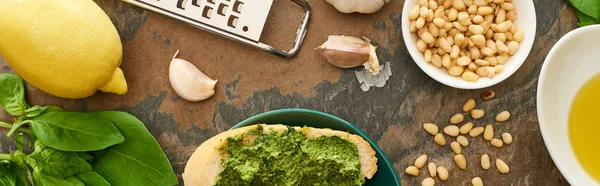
[0,0,577,186]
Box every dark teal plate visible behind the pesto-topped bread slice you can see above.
[231,109,400,186]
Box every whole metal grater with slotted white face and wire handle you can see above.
[122,0,311,58]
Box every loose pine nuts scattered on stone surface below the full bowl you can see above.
[404,90,513,186]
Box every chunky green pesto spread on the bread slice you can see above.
[215,127,365,186]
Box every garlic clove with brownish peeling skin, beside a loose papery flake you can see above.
[319,36,380,74]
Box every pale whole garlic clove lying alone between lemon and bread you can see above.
[169,51,217,101]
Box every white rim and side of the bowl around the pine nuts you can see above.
[402,0,536,89]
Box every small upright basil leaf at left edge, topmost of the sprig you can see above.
[0,73,28,116]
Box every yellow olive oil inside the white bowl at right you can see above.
[569,74,600,182]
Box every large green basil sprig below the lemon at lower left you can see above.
[0,74,178,186]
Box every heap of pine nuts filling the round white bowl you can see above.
[408,0,525,82]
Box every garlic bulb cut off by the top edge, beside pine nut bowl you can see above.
[326,0,390,14]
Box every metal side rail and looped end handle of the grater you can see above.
[121,0,312,58]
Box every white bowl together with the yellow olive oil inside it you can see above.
[537,25,600,186]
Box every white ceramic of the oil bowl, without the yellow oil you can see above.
[537,25,600,186]
